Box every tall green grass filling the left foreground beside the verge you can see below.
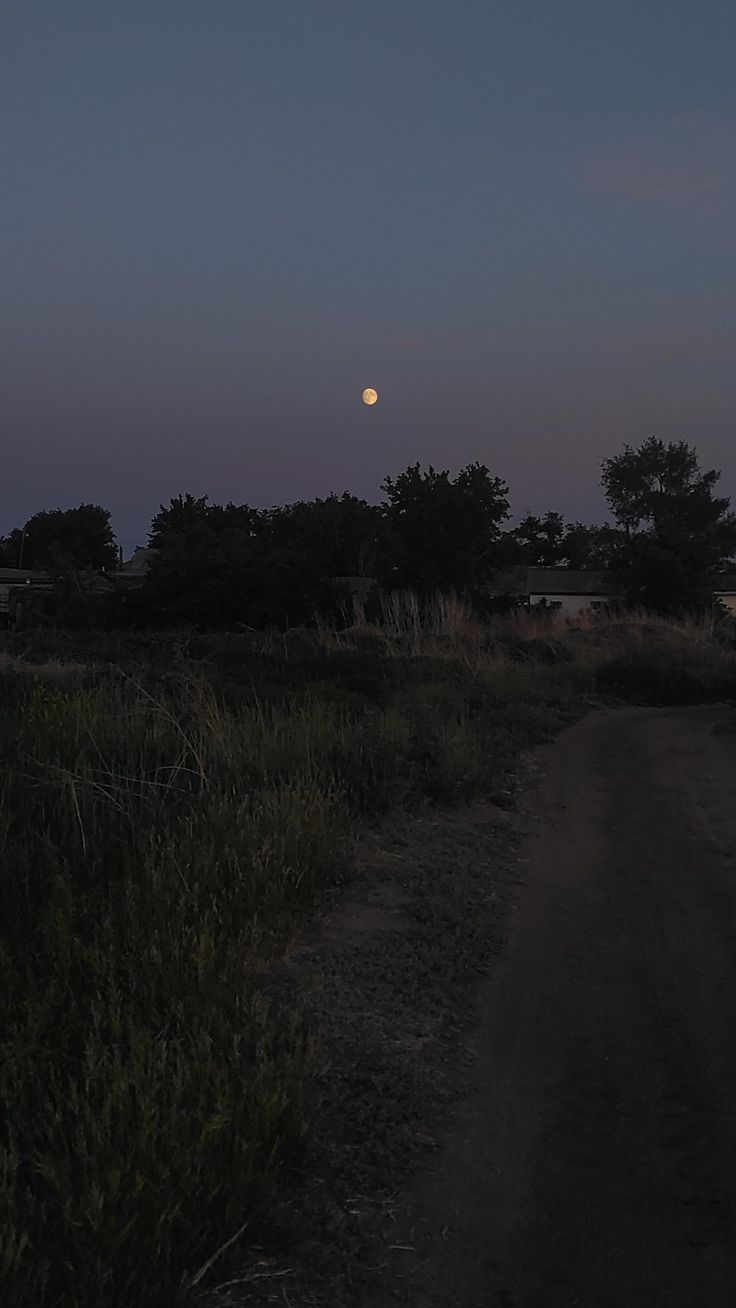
[0,666,515,1308]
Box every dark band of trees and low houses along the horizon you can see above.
[0,437,736,630]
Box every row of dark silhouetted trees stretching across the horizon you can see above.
[0,437,736,628]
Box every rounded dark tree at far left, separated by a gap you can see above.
[0,504,118,573]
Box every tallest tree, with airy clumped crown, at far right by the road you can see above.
[603,436,736,612]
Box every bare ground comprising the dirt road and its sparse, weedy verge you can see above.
[203,705,736,1308]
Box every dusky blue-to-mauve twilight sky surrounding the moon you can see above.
[0,0,736,555]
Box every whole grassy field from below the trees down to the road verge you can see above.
[0,596,736,1308]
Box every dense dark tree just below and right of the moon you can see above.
[380,463,509,595]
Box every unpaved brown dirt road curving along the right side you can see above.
[373,706,736,1308]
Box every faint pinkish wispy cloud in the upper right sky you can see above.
[582,111,736,218]
